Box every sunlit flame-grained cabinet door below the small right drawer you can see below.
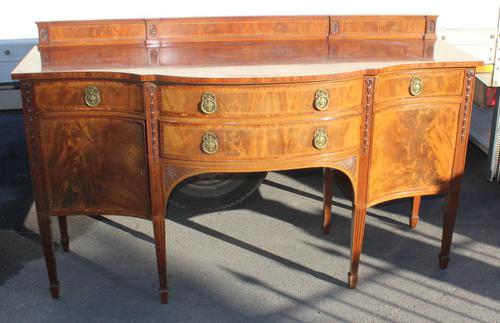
[368,102,460,205]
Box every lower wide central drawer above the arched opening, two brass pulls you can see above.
[160,116,361,160]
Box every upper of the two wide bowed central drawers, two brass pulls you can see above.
[160,78,363,117]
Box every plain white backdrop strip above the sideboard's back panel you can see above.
[0,0,500,39]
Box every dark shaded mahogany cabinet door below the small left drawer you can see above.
[40,117,149,217]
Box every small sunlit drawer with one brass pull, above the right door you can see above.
[375,69,464,103]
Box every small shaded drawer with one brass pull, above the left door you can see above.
[35,81,144,112]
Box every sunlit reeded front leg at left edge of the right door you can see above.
[348,206,366,288]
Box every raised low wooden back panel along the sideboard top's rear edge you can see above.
[37,15,437,48]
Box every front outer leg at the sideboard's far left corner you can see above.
[38,215,59,298]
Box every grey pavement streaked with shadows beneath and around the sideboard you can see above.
[0,113,500,323]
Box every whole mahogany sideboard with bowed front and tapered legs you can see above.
[12,16,481,303]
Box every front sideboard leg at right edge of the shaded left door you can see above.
[153,214,168,304]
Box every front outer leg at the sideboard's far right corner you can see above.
[439,191,460,269]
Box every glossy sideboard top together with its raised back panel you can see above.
[12,16,482,84]
